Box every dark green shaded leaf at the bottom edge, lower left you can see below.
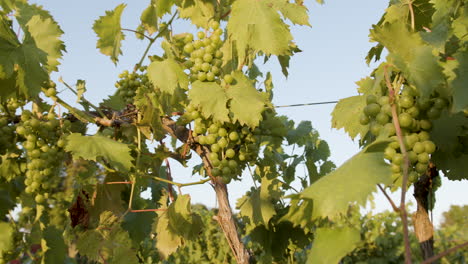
[41,226,68,263]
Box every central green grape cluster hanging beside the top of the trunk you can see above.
[182,105,258,183]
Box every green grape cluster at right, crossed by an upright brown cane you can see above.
[360,87,447,183]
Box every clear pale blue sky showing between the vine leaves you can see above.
[31,0,468,226]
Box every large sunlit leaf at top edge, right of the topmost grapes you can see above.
[227,0,293,61]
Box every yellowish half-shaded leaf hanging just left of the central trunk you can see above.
[153,194,202,258]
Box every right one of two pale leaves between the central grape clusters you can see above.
[227,72,266,128]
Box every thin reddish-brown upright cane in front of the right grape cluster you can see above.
[384,65,411,264]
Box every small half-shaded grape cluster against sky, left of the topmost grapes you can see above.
[115,66,151,104]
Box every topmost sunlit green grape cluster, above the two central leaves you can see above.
[183,21,233,84]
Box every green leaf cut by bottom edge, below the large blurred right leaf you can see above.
[307,227,361,264]
